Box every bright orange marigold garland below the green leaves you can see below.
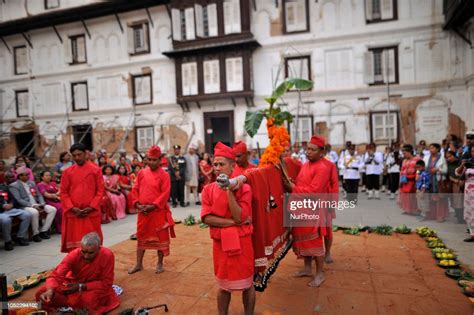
[258,118,290,168]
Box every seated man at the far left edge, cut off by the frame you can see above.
[0,172,32,251]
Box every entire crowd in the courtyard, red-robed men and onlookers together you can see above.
[0,132,474,313]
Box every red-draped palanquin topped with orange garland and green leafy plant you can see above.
[243,79,313,291]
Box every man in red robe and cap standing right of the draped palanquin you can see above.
[284,136,331,287]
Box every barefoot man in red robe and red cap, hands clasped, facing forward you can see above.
[128,145,175,274]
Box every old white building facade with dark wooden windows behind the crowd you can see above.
[0,0,474,167]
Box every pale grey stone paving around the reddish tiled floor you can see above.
[0,193,474,279]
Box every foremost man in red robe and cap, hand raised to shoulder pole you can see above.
[201,142,255,314]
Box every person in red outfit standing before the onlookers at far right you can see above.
[398,144,421,215]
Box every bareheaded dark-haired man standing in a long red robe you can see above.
[60,143,104,253]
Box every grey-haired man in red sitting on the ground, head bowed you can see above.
[36,232,120,314]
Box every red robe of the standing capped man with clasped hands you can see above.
[132,167,175,256]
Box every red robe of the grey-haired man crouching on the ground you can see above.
[36,247,120,314]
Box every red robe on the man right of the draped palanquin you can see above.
[291,159,331,257]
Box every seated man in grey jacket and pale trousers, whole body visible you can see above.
[10,166,57,242]
